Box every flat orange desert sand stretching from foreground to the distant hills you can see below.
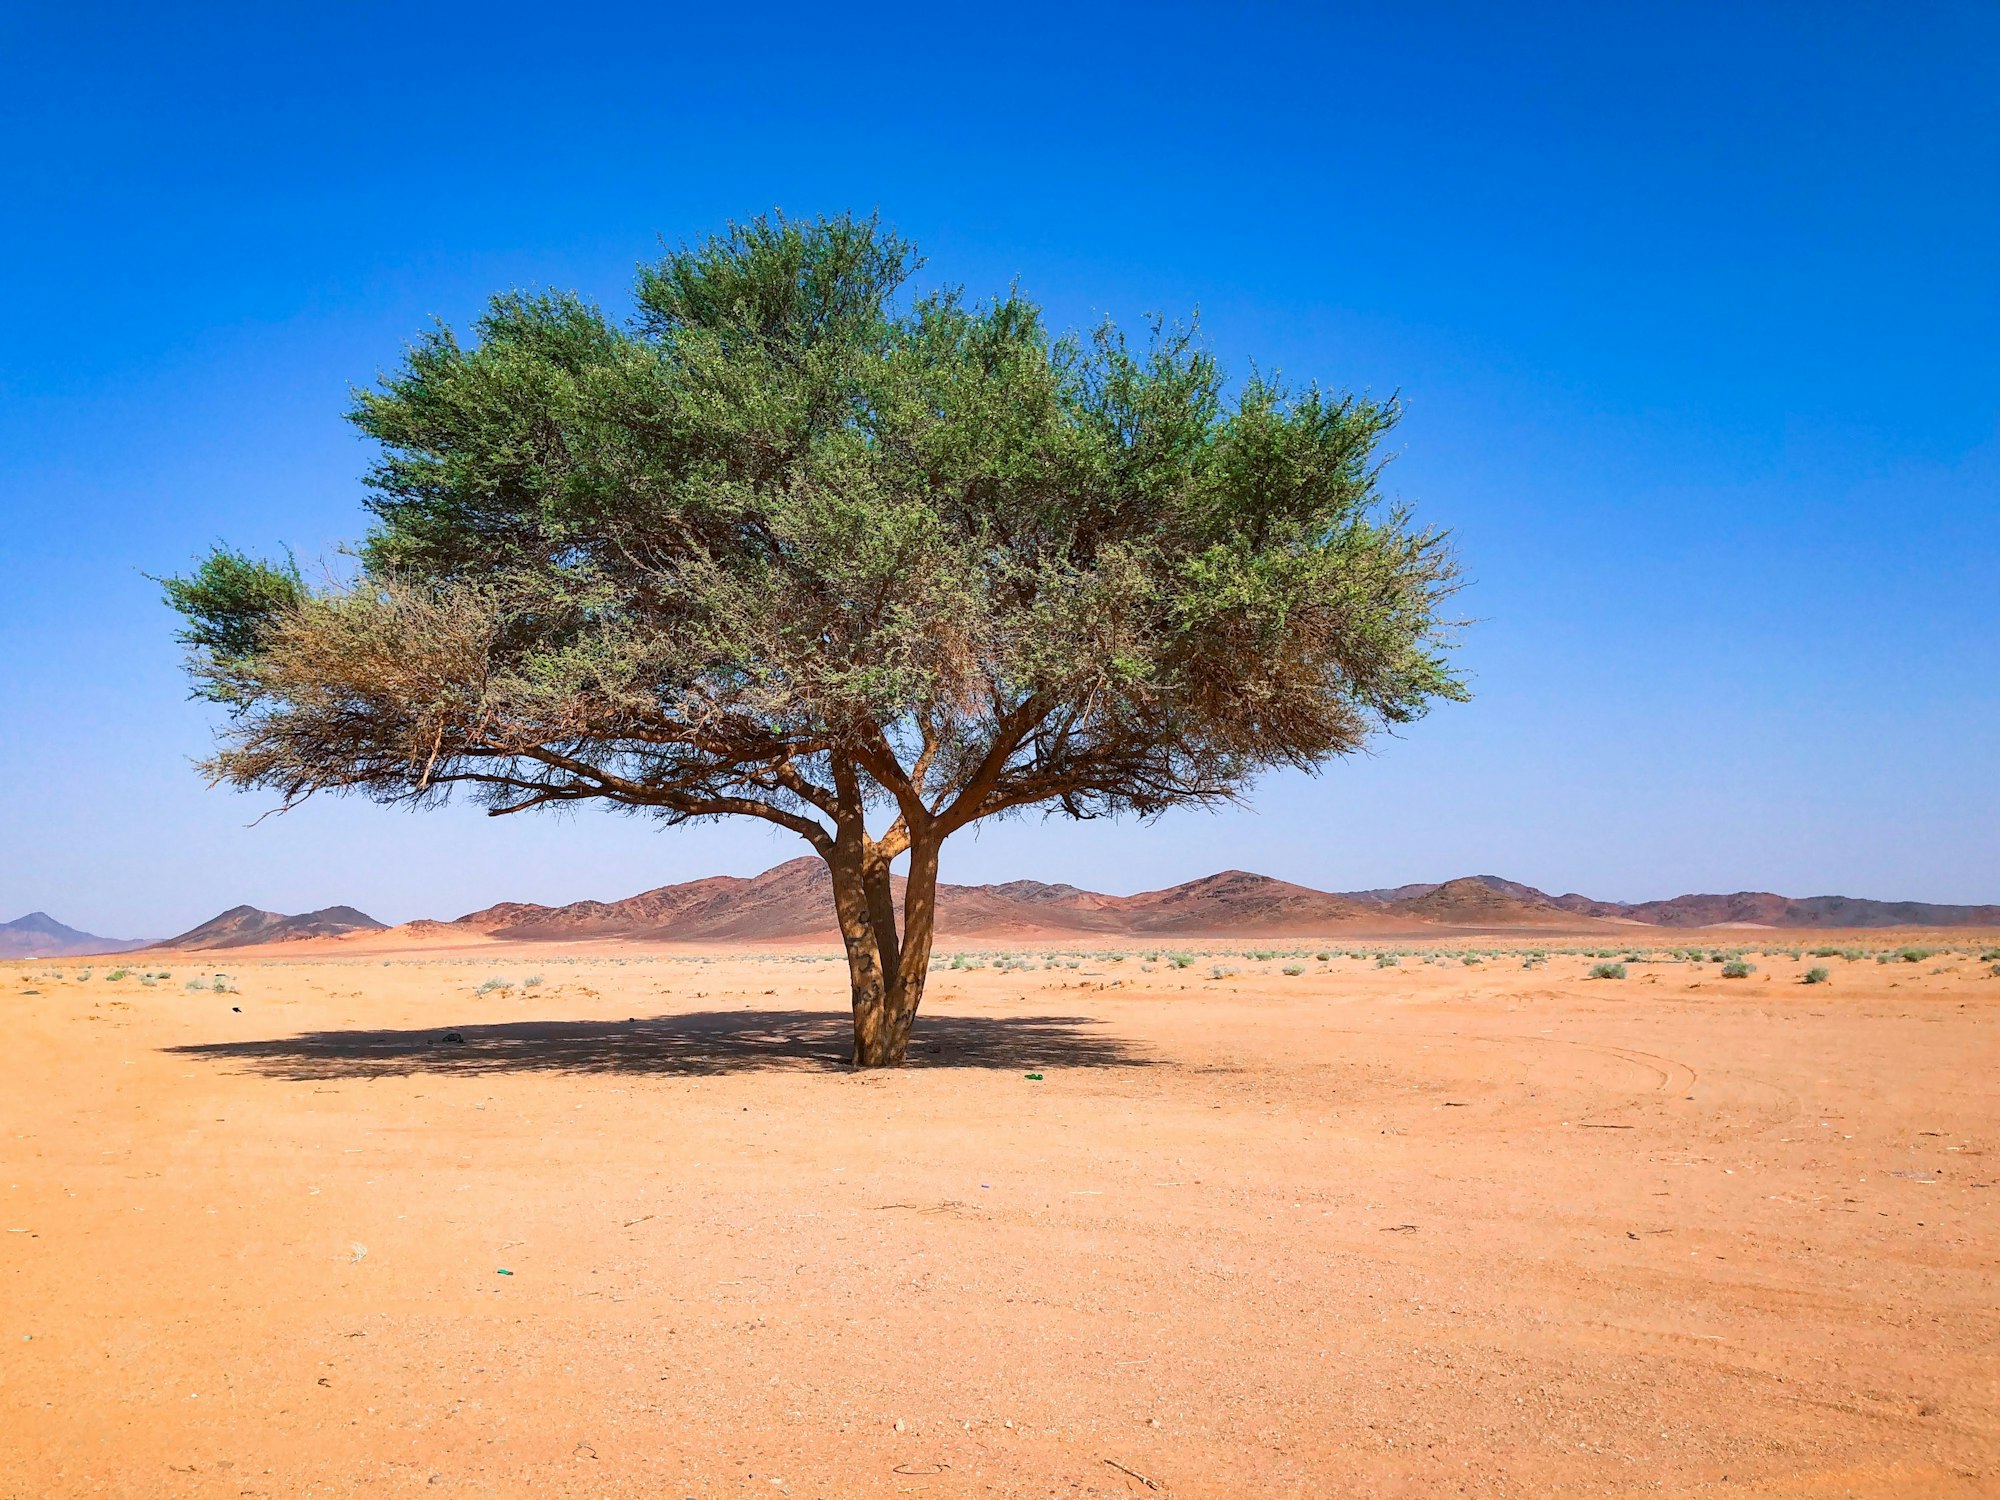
[0,934,2000,1500]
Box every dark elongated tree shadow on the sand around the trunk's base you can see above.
[166,1010,1154,1082]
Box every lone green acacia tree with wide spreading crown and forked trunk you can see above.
[166,218,1464,1066]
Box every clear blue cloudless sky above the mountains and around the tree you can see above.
[0,2,2000,936]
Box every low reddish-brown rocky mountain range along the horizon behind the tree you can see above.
[11,856,2000,958]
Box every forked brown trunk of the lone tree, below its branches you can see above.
[828,840,938,1068]
